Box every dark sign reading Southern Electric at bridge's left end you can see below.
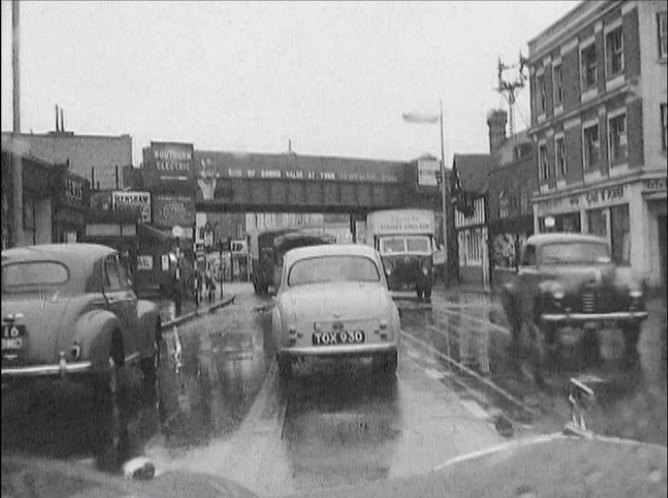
[143,142,194,192]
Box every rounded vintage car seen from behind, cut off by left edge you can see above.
[2,244,161,399]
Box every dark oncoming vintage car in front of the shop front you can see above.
[502,233,647,358]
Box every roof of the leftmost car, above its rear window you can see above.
[2,243,116,269]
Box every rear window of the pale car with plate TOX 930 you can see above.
[288,255,380,287]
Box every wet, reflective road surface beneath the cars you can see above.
[2,284,666,495]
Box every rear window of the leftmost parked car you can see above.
[2,261,70,294]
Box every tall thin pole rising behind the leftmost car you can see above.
[12,0,23,247]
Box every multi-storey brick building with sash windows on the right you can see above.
[528,0,668,285]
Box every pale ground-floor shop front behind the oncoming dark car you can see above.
[534,176,666,287]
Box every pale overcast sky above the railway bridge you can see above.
[2,0,577,165]
